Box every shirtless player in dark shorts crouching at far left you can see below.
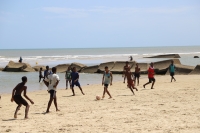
[11,76,34,119]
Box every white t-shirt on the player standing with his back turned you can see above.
[46,74,59,91]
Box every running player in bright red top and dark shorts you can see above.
[143,62,156,89]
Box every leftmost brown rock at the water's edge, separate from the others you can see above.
[4,61,35,72]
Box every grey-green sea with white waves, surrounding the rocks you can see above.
[0,46,200,93]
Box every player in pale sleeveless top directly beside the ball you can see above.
[102,66,113,99]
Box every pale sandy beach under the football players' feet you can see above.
[0,75,200,133]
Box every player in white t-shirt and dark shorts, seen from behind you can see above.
[43,67,60,113]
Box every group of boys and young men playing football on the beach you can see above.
[11,61,176,119]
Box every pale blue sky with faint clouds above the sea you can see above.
[0,0,200,49]
